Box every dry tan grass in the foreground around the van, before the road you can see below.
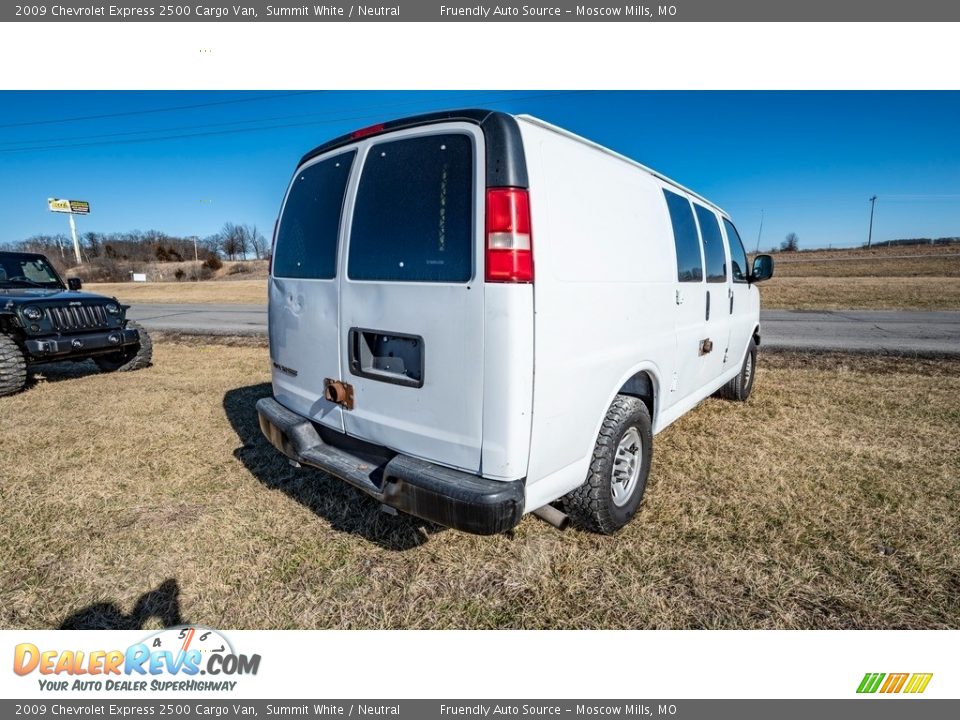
[0,337,960,628]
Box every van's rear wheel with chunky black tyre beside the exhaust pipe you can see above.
[563,395,653,535]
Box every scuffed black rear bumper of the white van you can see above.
[257,398,524,535]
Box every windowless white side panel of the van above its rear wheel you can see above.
[520,119,676,497]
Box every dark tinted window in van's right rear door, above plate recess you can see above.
[347,134,474,282]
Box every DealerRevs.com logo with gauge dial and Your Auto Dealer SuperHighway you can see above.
[13,626,260,692]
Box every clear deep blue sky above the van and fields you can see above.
[0,90,960,250]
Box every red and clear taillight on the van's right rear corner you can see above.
[486,188,533,283]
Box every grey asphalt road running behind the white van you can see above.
[130,304,960,356]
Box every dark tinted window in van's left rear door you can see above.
[273,151,356,280]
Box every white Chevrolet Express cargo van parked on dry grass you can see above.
[257,110,773,534]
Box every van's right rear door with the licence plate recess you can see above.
[339,122,485,472]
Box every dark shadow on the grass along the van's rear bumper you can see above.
[223,383,444,550]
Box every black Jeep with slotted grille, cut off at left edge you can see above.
[0,252,153,396]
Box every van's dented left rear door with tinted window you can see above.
[269,149,358,432]
